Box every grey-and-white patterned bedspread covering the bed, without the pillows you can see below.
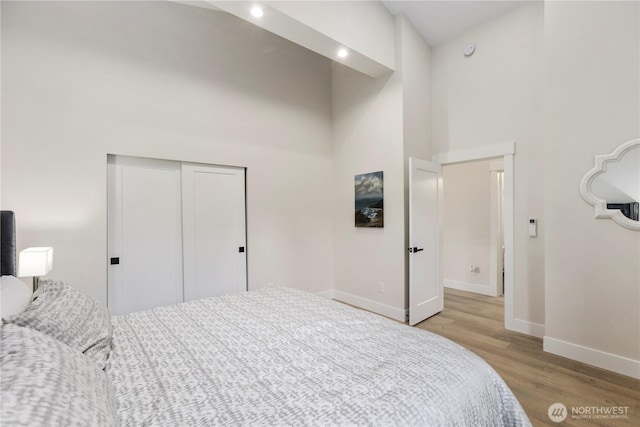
[106,288,530,426]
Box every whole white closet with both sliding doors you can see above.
[107,155,247,315]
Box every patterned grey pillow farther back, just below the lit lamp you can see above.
[3,280,113,369]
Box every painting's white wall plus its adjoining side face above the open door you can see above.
[333,16,431,320]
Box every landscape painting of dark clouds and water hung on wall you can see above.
[355,171,384,227]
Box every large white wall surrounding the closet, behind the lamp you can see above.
[1,2,336,301]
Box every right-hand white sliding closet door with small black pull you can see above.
[182,163,247,301]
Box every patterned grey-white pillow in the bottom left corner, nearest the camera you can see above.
[0,324,119,426]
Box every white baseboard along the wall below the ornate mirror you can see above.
[543,337,640,379]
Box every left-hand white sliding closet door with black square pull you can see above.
[107,156,183,315]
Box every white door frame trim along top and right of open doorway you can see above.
[433,141,519,331]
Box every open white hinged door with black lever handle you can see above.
[409,158,443,326]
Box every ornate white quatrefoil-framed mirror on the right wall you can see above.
[580,138,640,230]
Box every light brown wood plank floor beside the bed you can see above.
[417,289,640,427]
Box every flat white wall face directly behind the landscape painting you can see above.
[333,64,404,317]
